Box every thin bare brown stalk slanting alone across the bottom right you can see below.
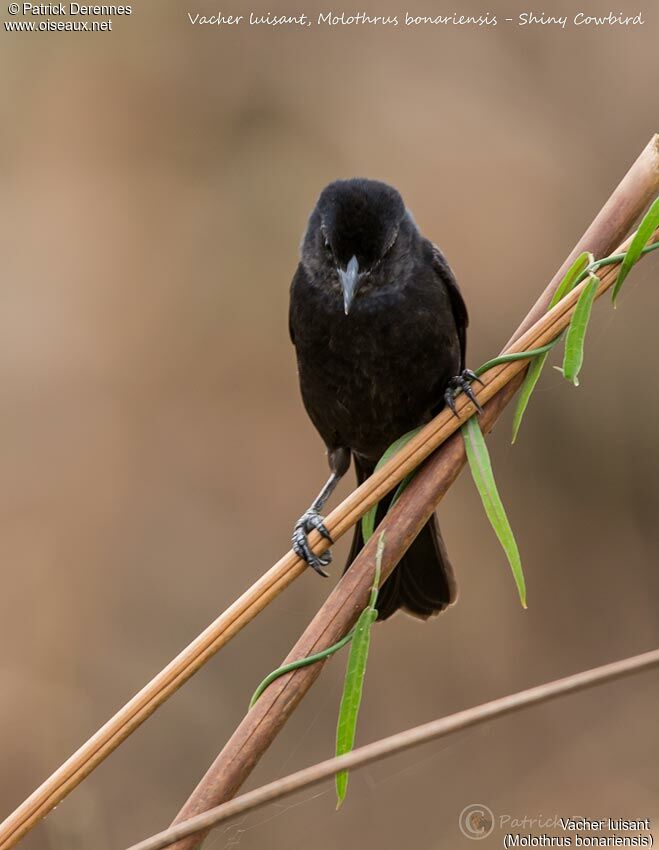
[128,649,659,850]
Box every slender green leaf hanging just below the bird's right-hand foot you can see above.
[462,416,526,608]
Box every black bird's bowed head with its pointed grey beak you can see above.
[302,179,407,315]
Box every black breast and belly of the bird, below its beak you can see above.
[296,281,459,459]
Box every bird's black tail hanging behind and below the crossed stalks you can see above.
[346,457,457,620]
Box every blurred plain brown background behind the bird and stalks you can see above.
[0,0,659,850]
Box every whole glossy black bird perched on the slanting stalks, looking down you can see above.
[289,179,476,620]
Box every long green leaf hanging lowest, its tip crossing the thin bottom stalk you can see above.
[335,532,384,809]
